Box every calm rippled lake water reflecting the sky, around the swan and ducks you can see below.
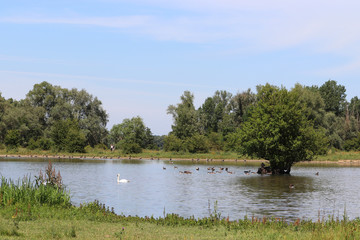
[0,159,360,220]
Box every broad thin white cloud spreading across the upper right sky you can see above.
[0,0,360,71]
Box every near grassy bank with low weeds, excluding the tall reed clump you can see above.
[0,197,360,240]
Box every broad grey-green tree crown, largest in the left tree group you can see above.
[26,82,108,147]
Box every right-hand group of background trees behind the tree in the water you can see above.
[164,80,360,152]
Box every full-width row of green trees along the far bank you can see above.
[0,80,360,158]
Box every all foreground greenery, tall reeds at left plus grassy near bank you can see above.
[0,163,360,240]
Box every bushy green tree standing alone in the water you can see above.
[238,84,327,174]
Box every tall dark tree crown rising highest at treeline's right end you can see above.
[319,80,346,116]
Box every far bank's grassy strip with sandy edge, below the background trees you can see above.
[0,148,360,165]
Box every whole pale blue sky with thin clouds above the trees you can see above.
[0,0,360,135]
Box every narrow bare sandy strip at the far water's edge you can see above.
[0,154,360,166]
